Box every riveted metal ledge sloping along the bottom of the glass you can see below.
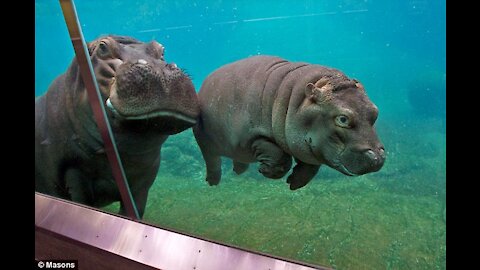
[35,193,328,270]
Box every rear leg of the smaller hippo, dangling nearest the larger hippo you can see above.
[193,125,222,186]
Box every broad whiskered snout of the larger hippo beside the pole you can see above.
[106,54,200,135]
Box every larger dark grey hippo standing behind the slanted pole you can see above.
[35,36,200,217]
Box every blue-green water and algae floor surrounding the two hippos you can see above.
[35,0,446,269]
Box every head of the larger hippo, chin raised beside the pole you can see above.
[89,36,200,134]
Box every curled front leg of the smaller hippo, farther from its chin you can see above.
[252,138,292,179]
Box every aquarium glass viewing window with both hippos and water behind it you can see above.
[35,0,446,269]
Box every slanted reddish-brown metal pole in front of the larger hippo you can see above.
[60,0,140,219]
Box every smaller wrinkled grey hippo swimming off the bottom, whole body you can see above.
[194,56,385,190]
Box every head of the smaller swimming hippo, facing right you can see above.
[291,73,385,176]
